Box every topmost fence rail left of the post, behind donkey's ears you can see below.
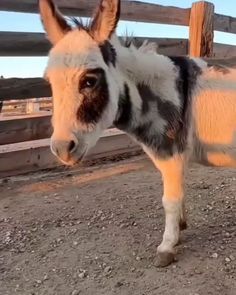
[0,0,190,26]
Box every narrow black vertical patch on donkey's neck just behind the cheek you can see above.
[114,83,132,131]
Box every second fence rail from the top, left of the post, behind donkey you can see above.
[0,32,187,56]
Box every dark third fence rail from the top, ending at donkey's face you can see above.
[0,78,52,101]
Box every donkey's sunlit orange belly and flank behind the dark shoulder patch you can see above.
[193,85,236,167]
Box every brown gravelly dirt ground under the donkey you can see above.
[0,156,236,295]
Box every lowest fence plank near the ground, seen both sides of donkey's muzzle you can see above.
[0,131,141,178]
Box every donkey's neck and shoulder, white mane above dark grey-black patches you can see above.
[112,36,197,157]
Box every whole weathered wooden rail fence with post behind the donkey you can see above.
[0,0,236,177]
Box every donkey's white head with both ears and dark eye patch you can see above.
[39,0,120,165]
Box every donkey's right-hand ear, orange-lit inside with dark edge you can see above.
[91,0,120,42]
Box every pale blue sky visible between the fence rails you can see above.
[0,0,236,78]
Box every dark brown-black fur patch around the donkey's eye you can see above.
[77,68,109,124]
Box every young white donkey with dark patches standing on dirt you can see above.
[39,0,236,266]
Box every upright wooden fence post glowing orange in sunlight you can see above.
[189,1,214,57]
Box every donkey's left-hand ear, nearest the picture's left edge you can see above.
[39,0,71,45]
